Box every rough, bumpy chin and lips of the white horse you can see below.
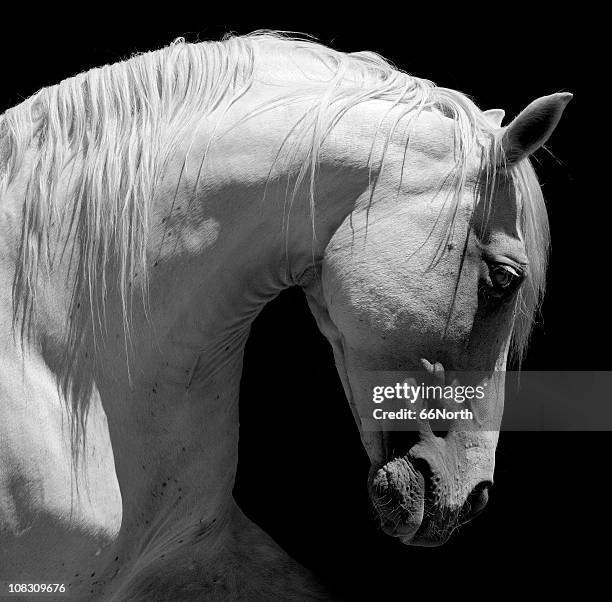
[369,457,457,547]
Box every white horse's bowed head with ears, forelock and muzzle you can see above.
[306,94,571,545]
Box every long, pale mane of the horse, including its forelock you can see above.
[0,31,548,448]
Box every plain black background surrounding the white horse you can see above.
[0,16,610,599]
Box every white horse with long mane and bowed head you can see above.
[0,32,571,600]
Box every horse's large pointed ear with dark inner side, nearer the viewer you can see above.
[502,92,572,165]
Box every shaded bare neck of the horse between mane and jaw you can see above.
[73,92,378,534]
